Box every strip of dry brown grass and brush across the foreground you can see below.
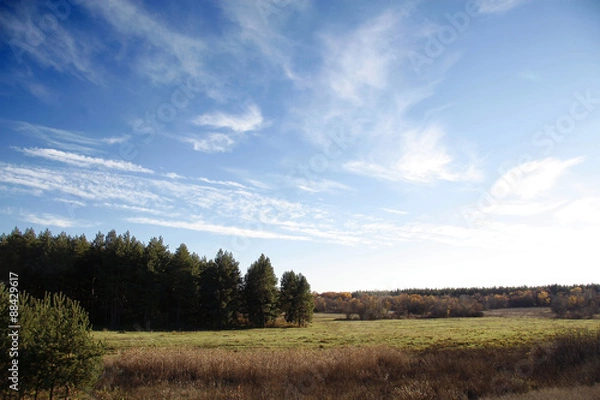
[85,333,600,400]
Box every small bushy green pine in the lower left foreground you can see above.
[19,293,103,399]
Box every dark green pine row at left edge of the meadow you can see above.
[0,228,314,330]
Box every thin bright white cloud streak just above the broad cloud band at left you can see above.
[18,148,154,174]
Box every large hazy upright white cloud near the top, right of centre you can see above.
[290,9,433,150]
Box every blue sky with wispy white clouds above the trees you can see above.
[0,0,600,292]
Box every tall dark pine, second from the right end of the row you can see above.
[244,254,278,328]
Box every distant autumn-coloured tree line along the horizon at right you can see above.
[315,284,600,320]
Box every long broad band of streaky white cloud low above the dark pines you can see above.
[0,164,332,240]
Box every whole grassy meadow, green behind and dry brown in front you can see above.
[88,312,600,400]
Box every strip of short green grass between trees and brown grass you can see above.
[93,314,600,352]
